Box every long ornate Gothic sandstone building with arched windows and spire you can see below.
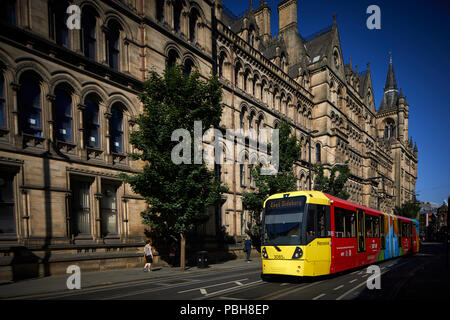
[0,0,417,276]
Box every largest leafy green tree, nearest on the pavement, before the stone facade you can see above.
[122,66,226,268]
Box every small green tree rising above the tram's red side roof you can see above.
[314,165,350,200]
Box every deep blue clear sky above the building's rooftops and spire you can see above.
[223,0,450,204]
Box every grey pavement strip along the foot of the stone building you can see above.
[0,254,261,299]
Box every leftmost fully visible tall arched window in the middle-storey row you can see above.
[18,78,42,137]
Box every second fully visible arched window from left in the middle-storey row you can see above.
[55,89,72,142]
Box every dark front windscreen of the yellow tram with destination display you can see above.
[262,196,306,245]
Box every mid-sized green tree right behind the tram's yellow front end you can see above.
[242,121,301,248]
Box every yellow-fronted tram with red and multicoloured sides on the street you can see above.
[261,191,419,278]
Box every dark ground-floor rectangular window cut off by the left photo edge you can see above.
[0,173,16,234]
